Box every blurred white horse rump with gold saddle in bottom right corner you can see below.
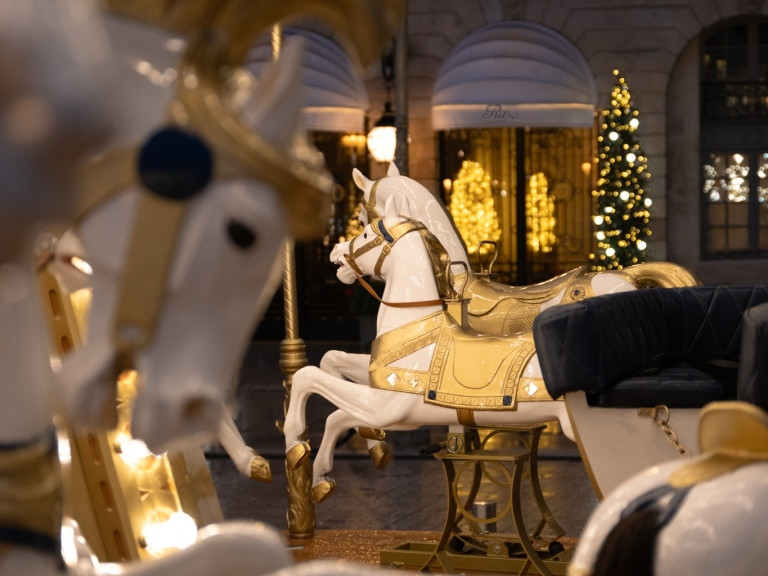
[568,402,768,576]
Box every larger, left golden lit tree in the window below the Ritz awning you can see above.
[448,160,501,254]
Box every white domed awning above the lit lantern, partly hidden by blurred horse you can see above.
[246,28,369,133]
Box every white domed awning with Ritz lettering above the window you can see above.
[432,22,597,130]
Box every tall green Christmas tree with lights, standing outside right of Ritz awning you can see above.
[590,70,651,271]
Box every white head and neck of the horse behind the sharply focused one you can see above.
[352,162,468,262]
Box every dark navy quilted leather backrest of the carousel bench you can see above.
[533,285,768,398]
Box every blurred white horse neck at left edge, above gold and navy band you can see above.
[0,262,53,445]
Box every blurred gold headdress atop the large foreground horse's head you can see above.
[88,0,404,239]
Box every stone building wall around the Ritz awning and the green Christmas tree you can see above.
[368,0,768,283]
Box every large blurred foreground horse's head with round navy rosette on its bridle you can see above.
[53,3,332,451]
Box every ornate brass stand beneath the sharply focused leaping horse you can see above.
[380,424,570,576]
